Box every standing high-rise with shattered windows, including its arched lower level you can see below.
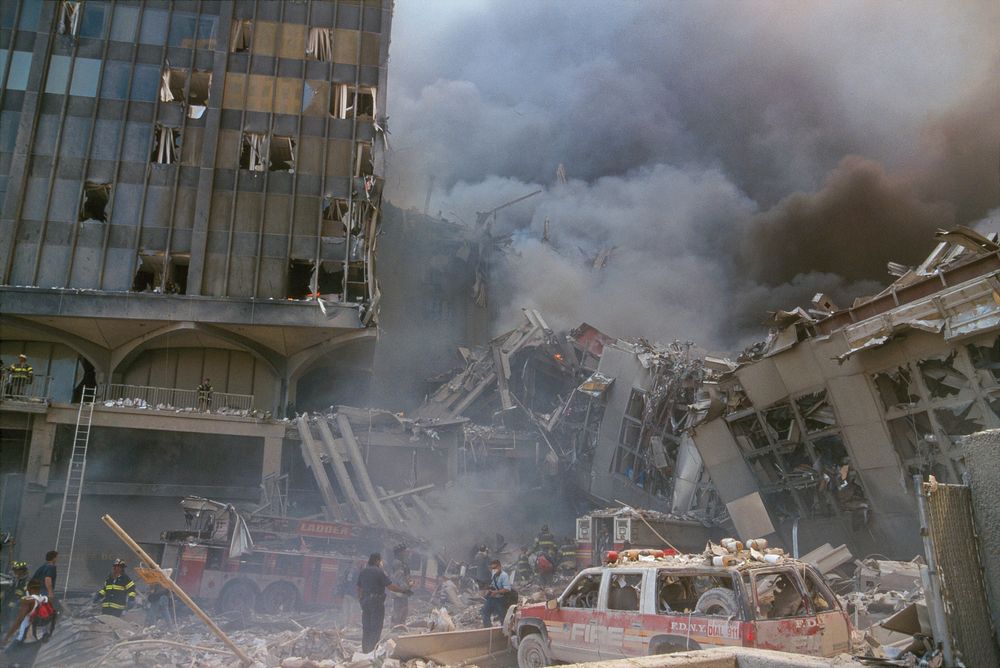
[0,0,392,579]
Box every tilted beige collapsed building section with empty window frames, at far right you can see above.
[690,228,1000,559]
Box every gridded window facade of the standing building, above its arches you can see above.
[0,0,389,301]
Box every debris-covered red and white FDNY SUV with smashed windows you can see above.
[504,555,851,668]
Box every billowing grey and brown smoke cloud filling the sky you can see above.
[387,0,1000,349]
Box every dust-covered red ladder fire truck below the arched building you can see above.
[160,497,437,613]
